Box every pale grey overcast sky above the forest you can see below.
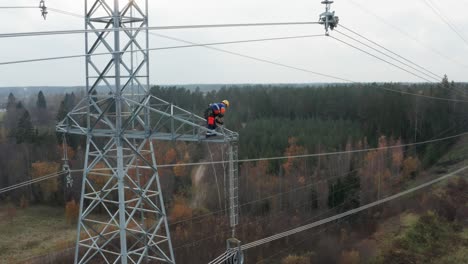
[0,0,468,87]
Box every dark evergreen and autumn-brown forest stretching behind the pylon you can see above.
[0,77,468,264]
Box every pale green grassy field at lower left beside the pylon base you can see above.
[0,206,76,263]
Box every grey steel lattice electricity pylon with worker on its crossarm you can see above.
[57,0,238,264]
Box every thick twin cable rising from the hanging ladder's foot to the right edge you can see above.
[241,166,468,250]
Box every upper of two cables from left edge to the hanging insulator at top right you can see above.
[0,21,318,38]
